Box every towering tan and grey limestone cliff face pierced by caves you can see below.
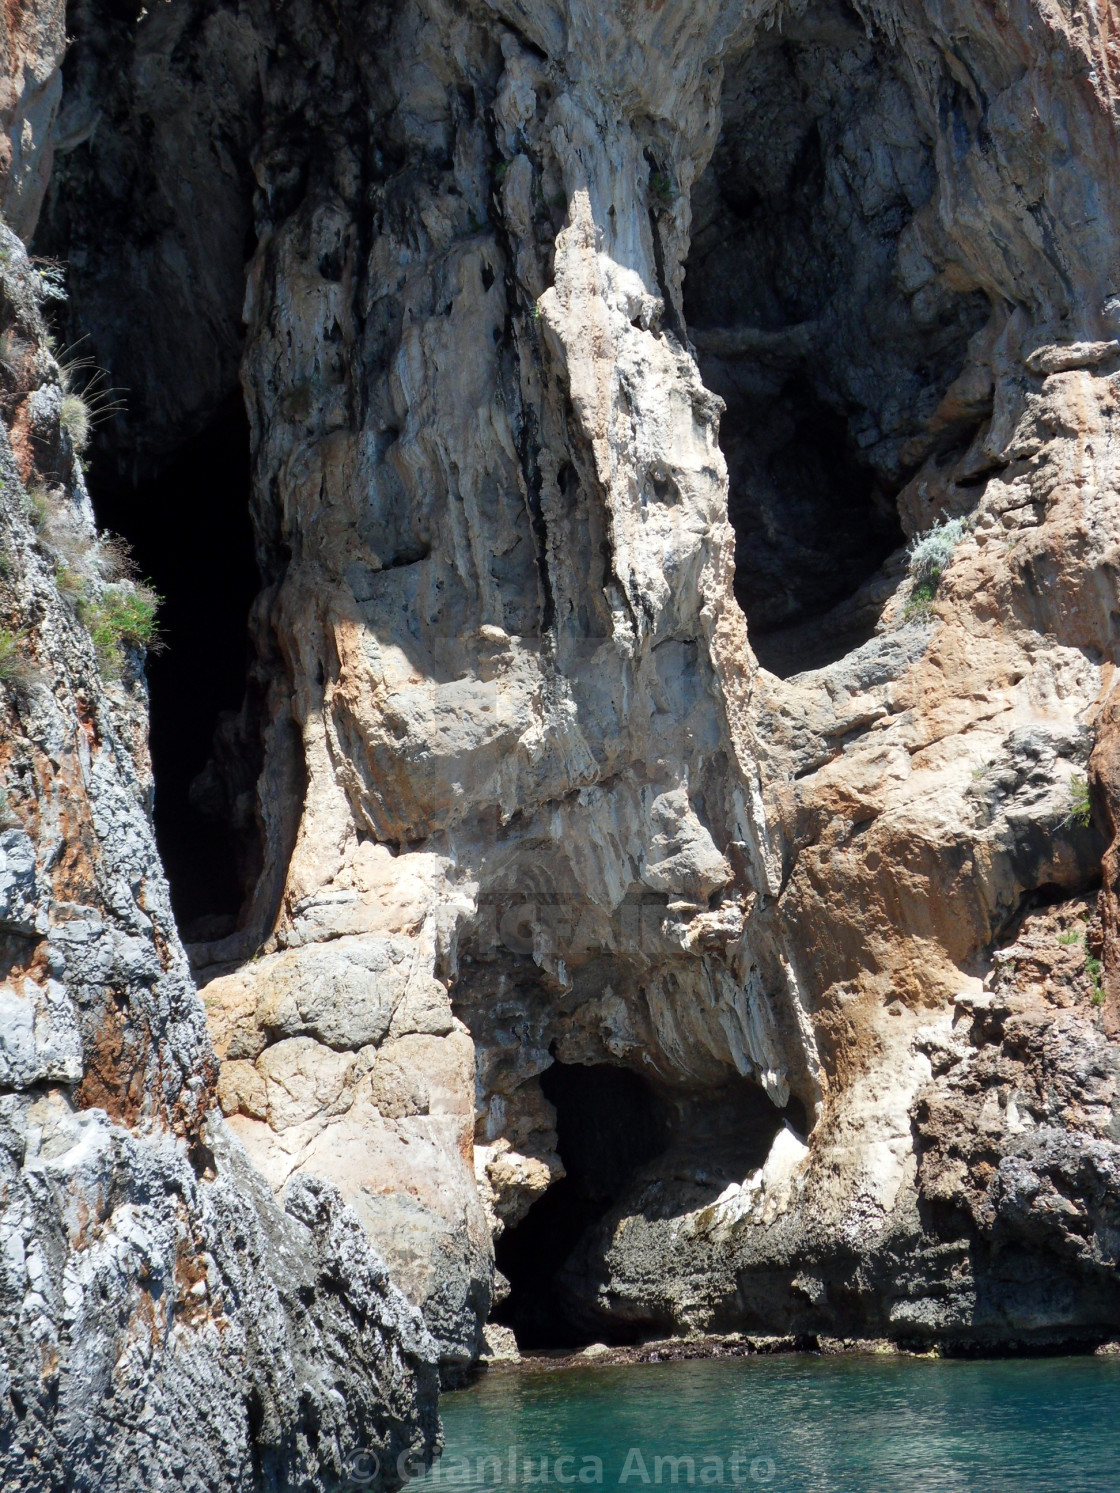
[10,0,1120,1451]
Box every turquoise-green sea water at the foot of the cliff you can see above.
[411,1356,1120,1493]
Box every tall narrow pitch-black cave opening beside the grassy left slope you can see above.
[90,394,261,941]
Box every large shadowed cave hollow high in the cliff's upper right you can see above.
[684,0,989,676]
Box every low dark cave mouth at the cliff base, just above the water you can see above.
[493,1060,806,1351]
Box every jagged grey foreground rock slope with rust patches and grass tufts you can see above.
[0,166,438,1493]
